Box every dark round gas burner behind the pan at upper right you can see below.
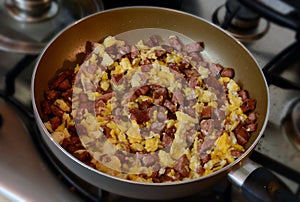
[212,0,269,42]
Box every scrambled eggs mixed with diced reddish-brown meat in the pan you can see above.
[41,35,258,183]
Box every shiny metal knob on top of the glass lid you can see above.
[5,0,58,22]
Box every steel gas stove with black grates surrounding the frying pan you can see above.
[0,0,300,202]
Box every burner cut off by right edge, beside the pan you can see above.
[283,100,300,151]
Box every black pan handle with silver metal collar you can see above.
[228,159,299,202]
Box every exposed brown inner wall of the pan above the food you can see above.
[33,5,268,197]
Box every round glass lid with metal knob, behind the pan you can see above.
[0,0,103,55]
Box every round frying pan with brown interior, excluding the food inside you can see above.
[32,7,298,202]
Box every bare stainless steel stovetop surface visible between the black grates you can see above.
[0,0,300,201]
